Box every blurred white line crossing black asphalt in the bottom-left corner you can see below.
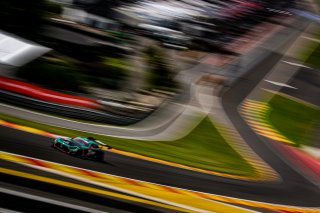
[0,187,105,213]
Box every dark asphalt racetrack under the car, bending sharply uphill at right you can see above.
[0,17,320,210]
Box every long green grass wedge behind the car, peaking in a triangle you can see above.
[0,114,255,177]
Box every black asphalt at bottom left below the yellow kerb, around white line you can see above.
[0,174,176,213]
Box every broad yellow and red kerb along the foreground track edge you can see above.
[0,151,320,213]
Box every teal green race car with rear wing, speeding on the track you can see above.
[52,137,112,161]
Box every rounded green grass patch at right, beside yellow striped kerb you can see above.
[269,95,320,147]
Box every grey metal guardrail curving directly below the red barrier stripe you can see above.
[0,90,152,125]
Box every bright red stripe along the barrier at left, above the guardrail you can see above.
[0,76,101,109]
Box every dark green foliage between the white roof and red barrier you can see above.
[17,59,84,92]
